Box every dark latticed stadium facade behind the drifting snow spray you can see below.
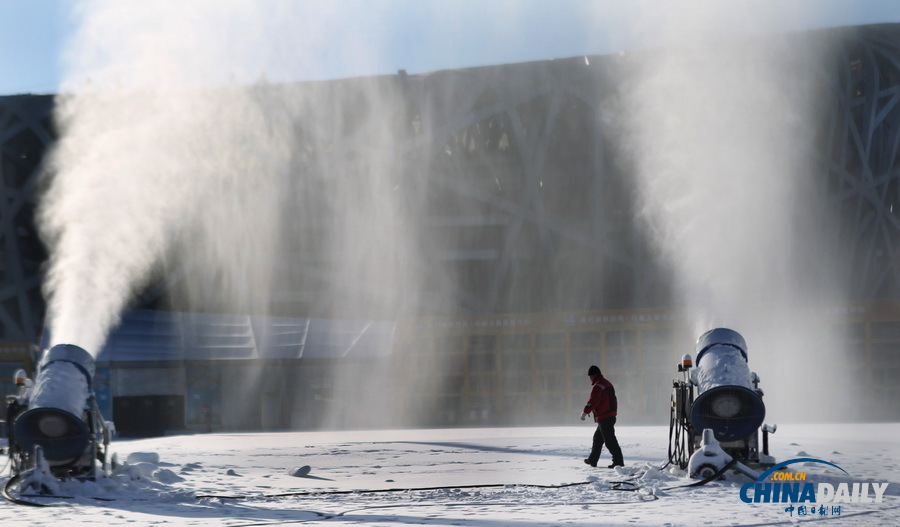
[0,25,900,427]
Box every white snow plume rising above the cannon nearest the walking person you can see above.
[622,2,840,417]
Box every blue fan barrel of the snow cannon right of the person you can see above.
[690,328,766,441]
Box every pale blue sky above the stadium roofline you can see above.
[0,0,900,95]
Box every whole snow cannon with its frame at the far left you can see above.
[7,344,109,478]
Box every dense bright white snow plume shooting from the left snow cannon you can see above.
[39,1,298,353]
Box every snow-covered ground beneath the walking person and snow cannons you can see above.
[0,423,900,527]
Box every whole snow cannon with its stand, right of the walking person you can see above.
[669,328,774,476]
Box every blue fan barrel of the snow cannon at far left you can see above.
[13,344,95,462]
